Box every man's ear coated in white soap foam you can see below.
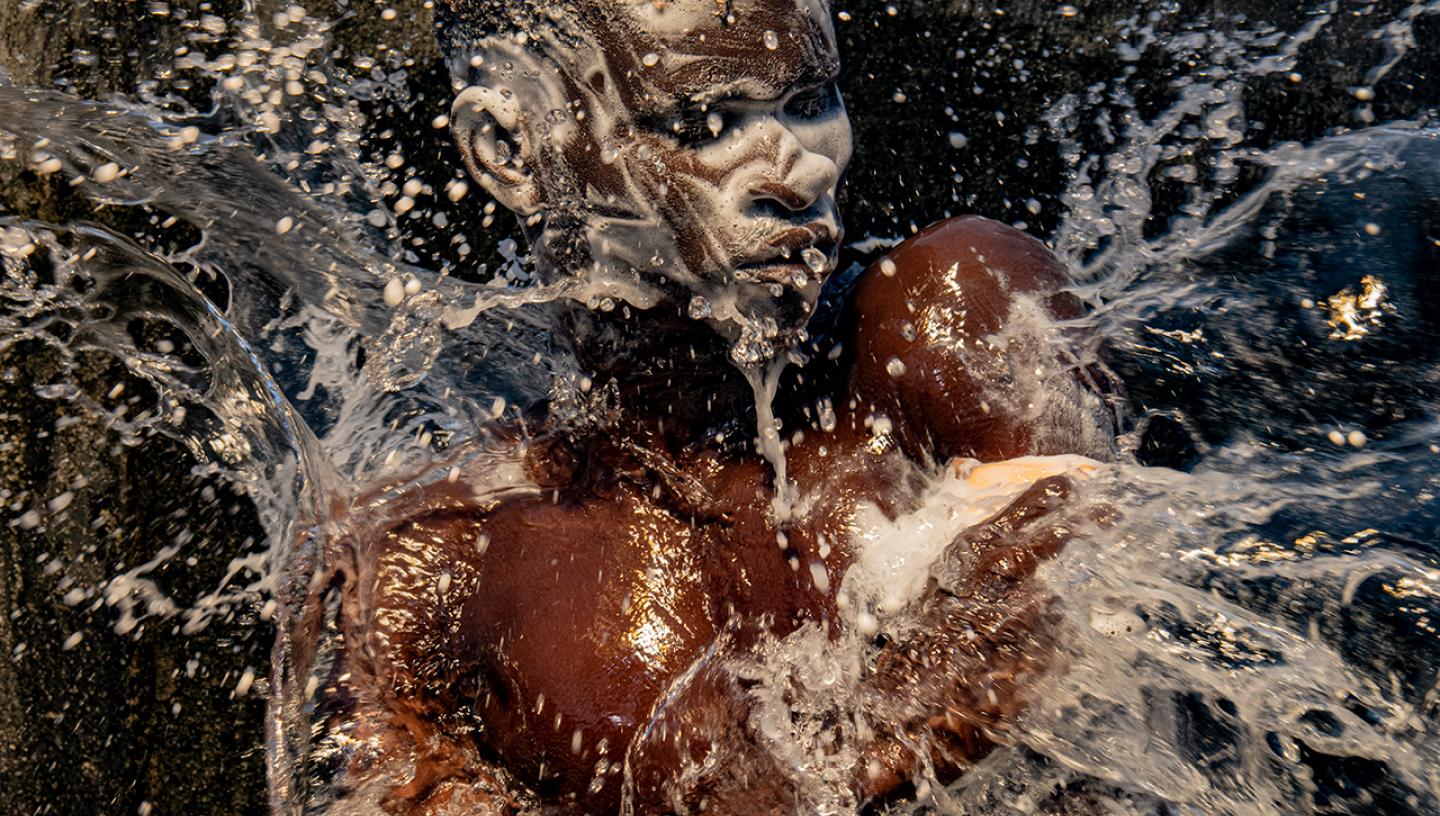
[451,85,543,217]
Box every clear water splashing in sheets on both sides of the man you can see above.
[0,1,1440,816]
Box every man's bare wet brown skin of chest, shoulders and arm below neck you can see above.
[324,219,1074,813]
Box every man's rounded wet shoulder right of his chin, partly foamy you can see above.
[851,217,1090,463]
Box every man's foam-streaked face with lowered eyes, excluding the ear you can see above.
[478,0,851,348]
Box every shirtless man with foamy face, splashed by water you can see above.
[270,0,1104,815]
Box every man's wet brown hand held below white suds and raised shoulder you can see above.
[857,476,1073,800]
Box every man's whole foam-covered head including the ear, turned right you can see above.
[439,0,851,358]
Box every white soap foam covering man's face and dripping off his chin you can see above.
[456,0,851,512]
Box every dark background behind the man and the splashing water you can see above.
[0,0,1440,815]
